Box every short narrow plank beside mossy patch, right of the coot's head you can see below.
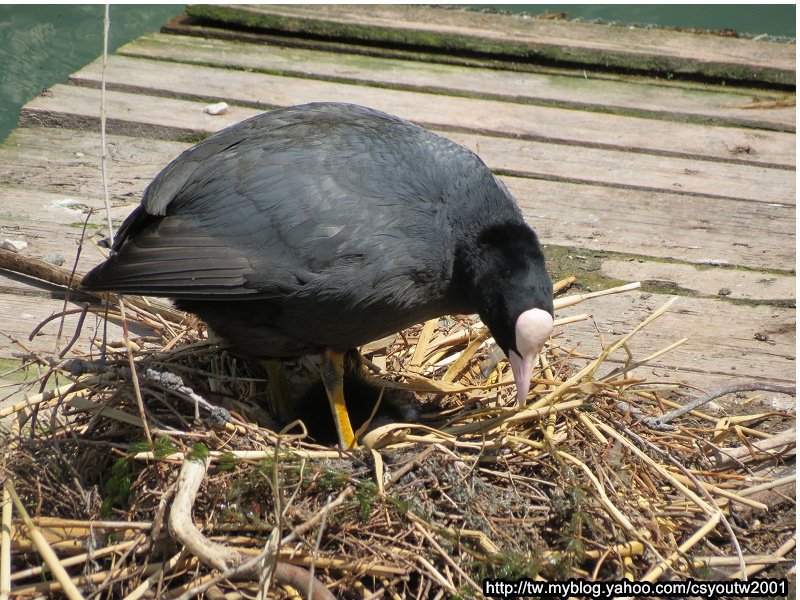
[599,258,797,302]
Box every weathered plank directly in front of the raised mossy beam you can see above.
[117,33,795,131]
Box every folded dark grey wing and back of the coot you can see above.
[83,104,468,308]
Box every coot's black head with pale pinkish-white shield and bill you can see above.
[460,222,553,405]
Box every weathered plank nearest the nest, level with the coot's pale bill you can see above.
[0,278,795,385]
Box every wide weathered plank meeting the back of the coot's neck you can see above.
[0,128,795,271]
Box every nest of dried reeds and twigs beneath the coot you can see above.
[0,274,795,599]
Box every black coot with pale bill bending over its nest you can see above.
[81,103,553,448]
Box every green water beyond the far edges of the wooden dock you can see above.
[0,4,795,140]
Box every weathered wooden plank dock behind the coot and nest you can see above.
[0,6,796,404]
